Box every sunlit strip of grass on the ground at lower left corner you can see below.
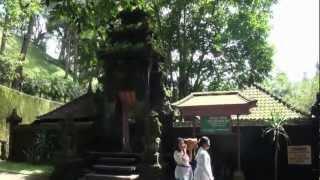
[0,161,53,175]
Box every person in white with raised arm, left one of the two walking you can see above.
[173,138,193,180]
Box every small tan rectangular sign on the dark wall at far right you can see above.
[288,145,312,165]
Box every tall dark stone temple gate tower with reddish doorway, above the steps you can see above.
[97,10,171,152]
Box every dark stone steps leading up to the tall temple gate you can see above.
[84,152,141,180]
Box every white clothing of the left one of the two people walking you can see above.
[173,151,193,180]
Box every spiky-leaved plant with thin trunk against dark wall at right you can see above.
[263,111,289,180]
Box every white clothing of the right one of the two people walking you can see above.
[194,147,214,180]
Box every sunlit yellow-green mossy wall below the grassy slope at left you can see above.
[0,85,62,139]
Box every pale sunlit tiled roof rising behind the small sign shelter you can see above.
[232,85,309,120]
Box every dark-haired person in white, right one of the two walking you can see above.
[194,136,214,180]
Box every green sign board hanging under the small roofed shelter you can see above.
[200,117,231,134]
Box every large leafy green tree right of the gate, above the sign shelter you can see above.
[150,0,274,98]
